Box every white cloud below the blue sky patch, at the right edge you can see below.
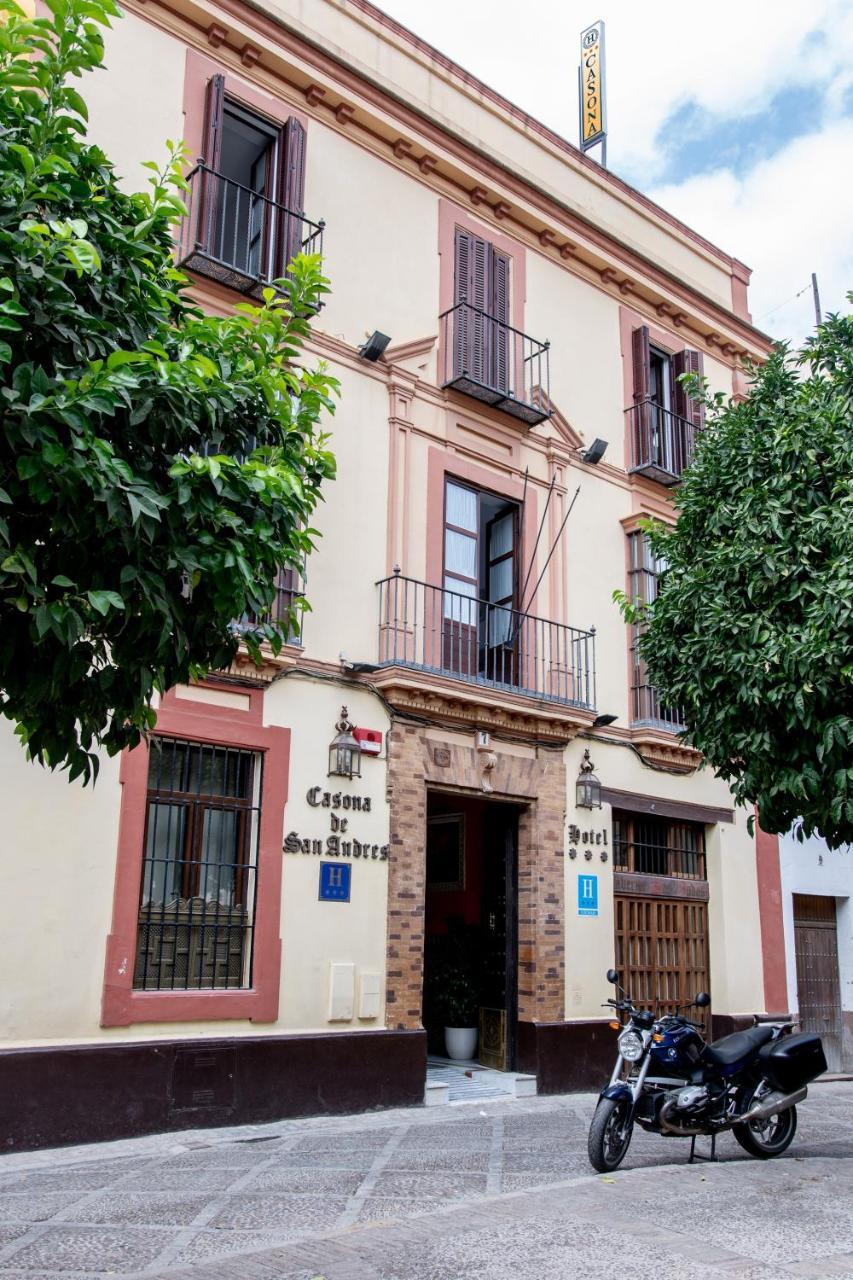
[649,120,853,342]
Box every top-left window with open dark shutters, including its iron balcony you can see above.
[179,76,323,294]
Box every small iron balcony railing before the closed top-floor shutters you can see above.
[438,302,551,426]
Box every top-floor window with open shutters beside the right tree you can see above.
[628,325,704,485]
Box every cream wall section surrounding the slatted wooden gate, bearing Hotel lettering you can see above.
[565,739,765,1019]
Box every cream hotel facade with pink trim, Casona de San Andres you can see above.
[0,0,781,1146]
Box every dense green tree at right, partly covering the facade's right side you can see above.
[621,307,853,847]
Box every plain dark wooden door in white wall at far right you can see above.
[794,893,841,1071]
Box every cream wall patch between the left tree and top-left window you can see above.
[81,13,186,191]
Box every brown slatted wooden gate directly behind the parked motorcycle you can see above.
[615,895,711,1028]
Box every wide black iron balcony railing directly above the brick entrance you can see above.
[377,573,596,709]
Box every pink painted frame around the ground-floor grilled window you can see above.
[101,681,291,1027]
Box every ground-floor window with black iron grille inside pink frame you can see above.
[133,737,261,991]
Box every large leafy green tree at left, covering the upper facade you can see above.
[0,0,337,781]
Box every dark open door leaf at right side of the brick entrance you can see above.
[479,804,519,1071]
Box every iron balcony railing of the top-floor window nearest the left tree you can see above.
[178,164,325,298]
